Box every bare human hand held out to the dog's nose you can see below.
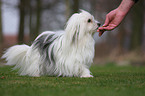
[97,8,126,36]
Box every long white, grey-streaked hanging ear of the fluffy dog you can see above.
[65,13,81,43]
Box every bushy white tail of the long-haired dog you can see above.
[2,45,30,68]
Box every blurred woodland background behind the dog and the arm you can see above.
[0,0,145,66]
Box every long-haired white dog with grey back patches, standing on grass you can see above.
[2,10,100,77]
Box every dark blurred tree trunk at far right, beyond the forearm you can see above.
[130,0,144,50]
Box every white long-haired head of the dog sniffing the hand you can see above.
[65,10,100,40]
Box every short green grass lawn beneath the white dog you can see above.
[0,65,145,96]
